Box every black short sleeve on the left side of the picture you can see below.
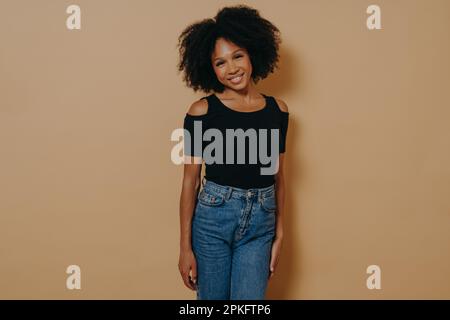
[183,113,206,157]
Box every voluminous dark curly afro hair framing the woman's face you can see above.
[177,5,281,92]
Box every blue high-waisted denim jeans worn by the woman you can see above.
[192,179,276,300]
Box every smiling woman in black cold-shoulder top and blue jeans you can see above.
[178,5,289,300]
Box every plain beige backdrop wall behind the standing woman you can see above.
[0,0,450,299]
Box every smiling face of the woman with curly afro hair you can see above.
[211,38,252,90]
